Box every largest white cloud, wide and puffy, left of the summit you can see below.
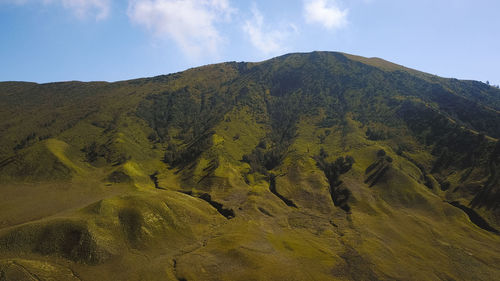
[127,0,235,58]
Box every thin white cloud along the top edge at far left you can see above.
[0,0,111,20]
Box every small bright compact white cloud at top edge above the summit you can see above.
[304,0,348,30]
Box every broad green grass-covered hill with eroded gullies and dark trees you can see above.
[0,52,500,281]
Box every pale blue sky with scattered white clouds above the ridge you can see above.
[0,0,500,84]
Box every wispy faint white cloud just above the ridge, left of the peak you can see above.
[243,5,297,54]
